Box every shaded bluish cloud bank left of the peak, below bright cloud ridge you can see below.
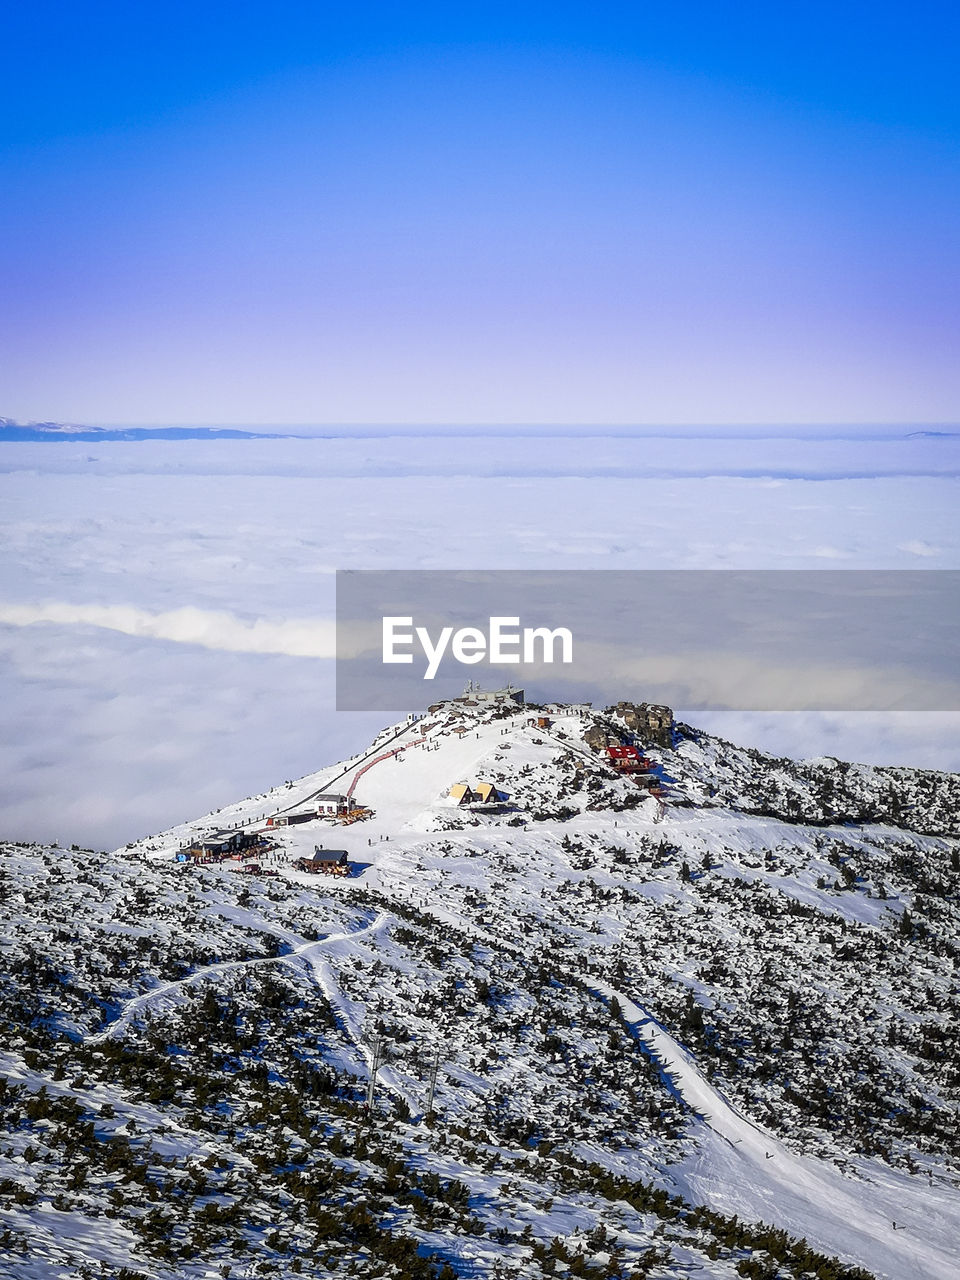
[0,626,383,849]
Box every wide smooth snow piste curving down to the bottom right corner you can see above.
[590,982,960,1280]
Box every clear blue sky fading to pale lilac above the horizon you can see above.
[0,4,960,424]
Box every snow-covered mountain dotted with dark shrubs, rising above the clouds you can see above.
[0,698,960,1280]
